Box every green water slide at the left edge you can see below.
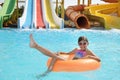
[0,0,17,28]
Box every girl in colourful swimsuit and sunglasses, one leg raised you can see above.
[30,34,100,76]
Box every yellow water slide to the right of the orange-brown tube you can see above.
[87,3,120,29]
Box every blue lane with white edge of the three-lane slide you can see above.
[18,0,35,28]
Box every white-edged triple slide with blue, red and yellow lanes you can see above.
[18,0,64,28]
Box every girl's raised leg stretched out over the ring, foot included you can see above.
[30,34,65,60]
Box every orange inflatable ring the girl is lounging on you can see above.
[47,55,100,72]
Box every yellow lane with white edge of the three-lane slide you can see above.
[44,0,64,29]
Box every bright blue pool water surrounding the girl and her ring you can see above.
[0,29,120,80]
